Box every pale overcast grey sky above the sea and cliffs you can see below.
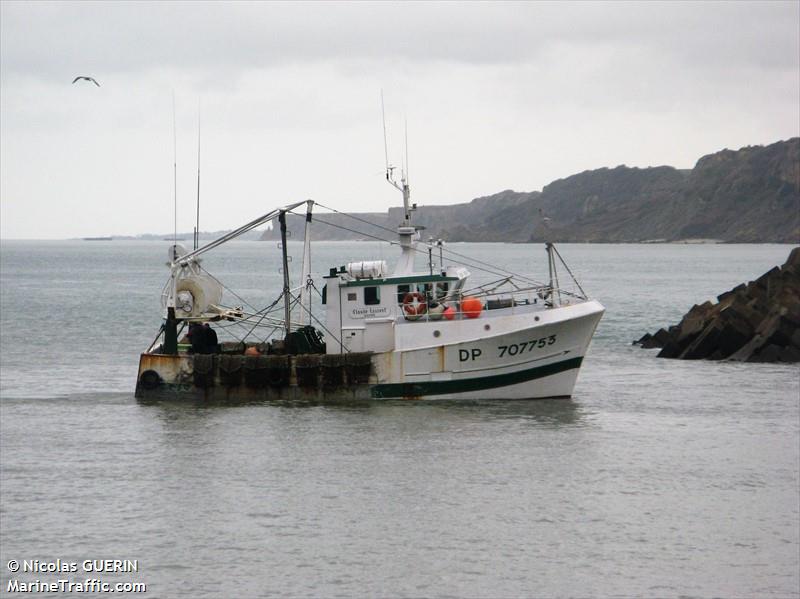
[0,1,800,239]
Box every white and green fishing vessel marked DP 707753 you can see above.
[136,166,604,401]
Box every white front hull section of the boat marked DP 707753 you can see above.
[371,301,604,400]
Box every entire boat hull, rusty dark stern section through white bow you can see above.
[136,301,604,402]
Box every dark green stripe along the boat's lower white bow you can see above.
[371,358,583,398]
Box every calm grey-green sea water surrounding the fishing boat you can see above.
[0,241,800,597]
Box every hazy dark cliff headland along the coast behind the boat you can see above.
[263,138,800,243]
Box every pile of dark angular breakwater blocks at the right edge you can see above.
[634,247,800,362]
